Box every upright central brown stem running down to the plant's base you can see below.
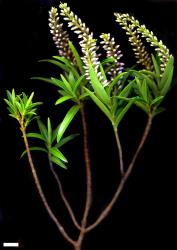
[75,103,92,247]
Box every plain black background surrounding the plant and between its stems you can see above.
[0,0,177,250]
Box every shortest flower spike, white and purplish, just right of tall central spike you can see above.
[100,33,124,80]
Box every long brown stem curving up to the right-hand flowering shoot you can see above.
[86,114,152,232]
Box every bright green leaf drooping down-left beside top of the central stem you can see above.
[57,106,79,142]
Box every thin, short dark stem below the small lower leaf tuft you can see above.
[49,155,81,230]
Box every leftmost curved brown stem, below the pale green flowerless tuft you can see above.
[21,127,75,246]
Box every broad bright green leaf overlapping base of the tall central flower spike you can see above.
[89,66,110,105]
